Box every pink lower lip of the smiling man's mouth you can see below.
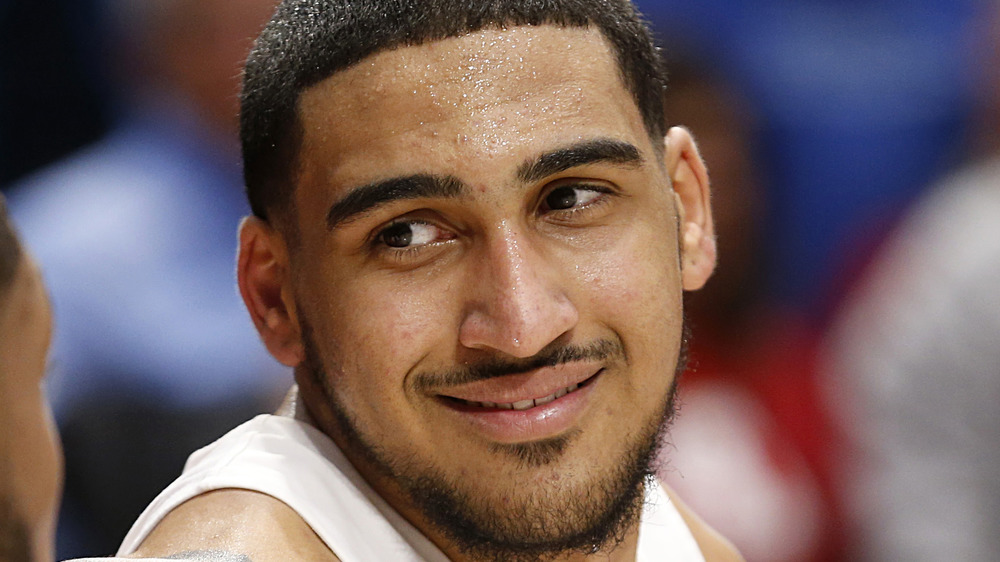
[441,370,603,444]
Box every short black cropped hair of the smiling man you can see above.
[240,0,665,219]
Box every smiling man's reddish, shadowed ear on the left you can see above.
[236,217,304,367]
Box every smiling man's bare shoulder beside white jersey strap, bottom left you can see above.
[131,489,339,562]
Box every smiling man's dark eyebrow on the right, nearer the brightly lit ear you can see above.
[517,138,644,183]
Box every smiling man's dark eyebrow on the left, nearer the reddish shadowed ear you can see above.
[326,174,466,230]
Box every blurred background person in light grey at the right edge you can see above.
[824,3,1000,562]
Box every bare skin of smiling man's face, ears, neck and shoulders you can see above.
[138,26,730,560]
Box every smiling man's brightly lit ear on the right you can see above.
[664,127,716,291]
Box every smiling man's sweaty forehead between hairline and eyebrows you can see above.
[299,26,649,203]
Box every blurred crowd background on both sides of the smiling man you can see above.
[0,0,1000,562]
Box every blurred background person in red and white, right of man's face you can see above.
[661,57,840,562]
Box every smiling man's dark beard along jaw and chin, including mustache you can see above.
[300,318,688,562]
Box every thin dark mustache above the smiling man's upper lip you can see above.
[413,339,625,390]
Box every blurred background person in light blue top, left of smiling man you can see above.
[4,0,287,557]
